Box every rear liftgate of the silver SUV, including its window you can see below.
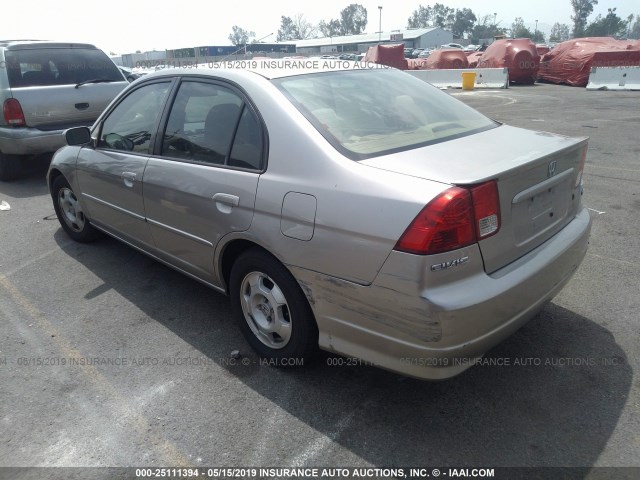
[5,44,128,130]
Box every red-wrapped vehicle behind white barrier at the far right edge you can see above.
[539,37,640,87]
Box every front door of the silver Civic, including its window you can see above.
[77,79,172,249]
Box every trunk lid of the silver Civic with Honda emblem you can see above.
[361,126,587,273]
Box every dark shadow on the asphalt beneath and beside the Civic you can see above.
[55,230,633,467]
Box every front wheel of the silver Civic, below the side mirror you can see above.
[51,175,101,243]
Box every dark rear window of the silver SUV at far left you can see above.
[5,48,124,88]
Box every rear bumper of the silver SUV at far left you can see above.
[0,122,92,155]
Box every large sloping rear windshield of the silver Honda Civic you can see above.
[274,69,497,160]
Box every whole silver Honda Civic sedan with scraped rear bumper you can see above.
[48,64,591,379]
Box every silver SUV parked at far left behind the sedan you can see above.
[0,40,127,180]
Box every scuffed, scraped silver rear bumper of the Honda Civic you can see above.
[292,209,591,379]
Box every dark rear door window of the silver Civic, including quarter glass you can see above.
[161,81,262,169]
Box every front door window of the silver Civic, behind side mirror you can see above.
[98,82,170,154]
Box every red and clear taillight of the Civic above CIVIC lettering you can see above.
[394,181,500,255]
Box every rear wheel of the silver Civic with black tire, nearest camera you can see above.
[229,248,319,366]
